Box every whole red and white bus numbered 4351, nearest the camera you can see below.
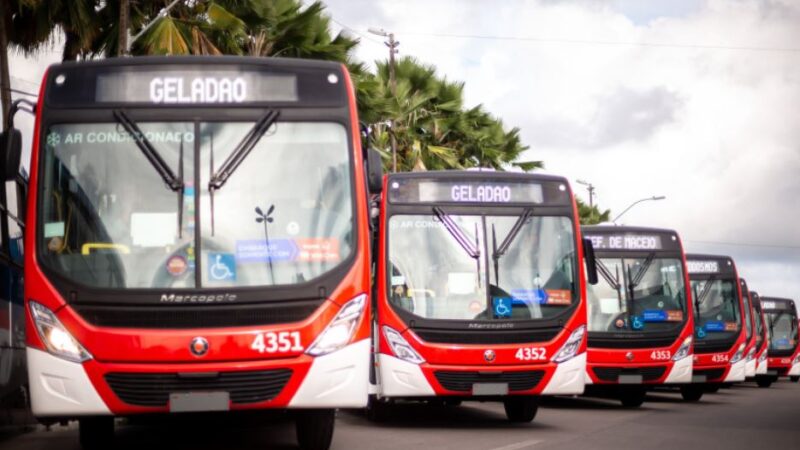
[11,57,381,448]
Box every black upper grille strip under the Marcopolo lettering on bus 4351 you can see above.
[72,300,320,329]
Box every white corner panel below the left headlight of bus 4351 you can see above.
[26,347,111,417]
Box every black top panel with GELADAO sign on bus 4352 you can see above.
[387,170,572,208]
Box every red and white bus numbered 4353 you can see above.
[583,226,694,407]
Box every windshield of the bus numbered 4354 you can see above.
[691,279,742,341]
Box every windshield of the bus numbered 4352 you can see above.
[388,215,578,320]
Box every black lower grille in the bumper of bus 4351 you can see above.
[105,369,292,407]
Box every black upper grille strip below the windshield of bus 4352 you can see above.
[412,327,564,344]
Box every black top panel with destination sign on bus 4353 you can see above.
[581,225,681,253]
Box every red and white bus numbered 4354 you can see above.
[682,254,747,397]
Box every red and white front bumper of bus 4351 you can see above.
[27,339,370,419]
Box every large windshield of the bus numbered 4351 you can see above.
[37,122,354,288]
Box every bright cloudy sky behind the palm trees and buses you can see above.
[6,0,800,300]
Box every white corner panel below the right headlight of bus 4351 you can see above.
[289,339,370,408]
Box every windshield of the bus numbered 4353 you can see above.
[587,257,686,332]
